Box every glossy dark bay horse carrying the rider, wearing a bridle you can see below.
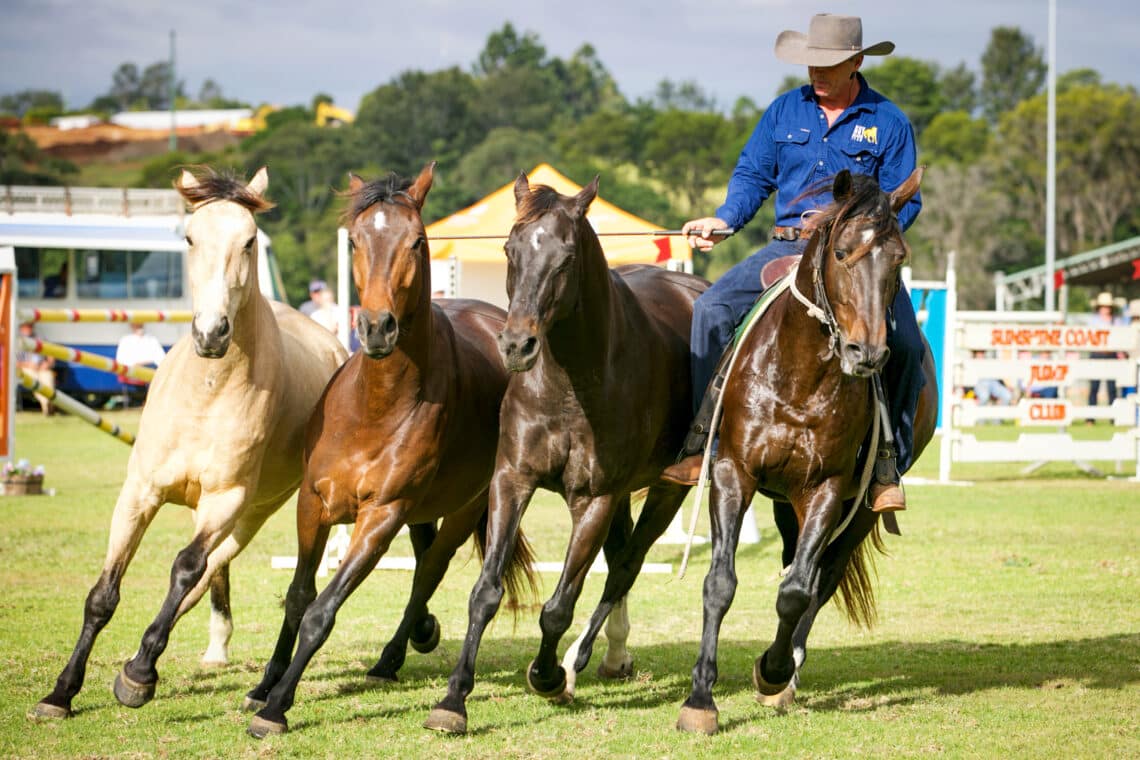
[677,170,937,734]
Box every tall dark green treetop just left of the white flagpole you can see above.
[980,26,1048,122]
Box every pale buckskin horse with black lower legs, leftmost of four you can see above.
[33,169,345,718]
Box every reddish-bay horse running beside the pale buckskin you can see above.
[246,162,534,737]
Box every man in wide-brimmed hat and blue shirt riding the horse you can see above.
[662,14,923,512]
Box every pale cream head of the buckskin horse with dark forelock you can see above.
[174,166,274,359]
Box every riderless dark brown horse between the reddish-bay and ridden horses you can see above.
[425,174,708,733]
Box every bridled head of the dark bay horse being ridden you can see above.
[804,167,922,377]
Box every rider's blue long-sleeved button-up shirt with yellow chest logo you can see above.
[716,74,922,230]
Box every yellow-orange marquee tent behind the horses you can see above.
[428,164,692,307]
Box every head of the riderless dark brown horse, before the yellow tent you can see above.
[498,174,597,373]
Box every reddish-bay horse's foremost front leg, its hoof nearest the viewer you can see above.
[246,501,408,738]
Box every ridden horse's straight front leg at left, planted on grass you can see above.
[677,459,756,734]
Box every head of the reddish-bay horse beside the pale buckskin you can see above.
[344,161,435,359]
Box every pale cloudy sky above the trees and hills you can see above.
[0,0,1140,111]
